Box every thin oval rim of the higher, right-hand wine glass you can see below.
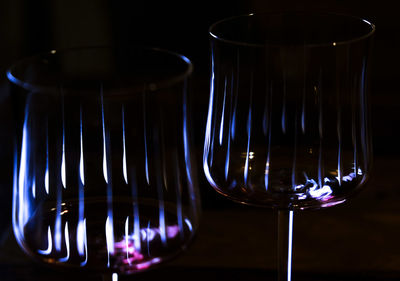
[208,12,376,48]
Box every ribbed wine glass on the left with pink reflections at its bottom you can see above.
[7,47,200,281]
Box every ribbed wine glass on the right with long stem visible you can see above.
[203,13,375,281]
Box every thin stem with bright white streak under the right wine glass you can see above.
[278,209,293,281]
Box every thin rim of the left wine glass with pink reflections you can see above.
[6,45,193,92]
